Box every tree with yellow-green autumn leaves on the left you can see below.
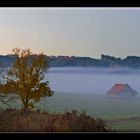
[0,48,53,110]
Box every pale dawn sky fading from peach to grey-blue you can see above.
[0,8,140,58]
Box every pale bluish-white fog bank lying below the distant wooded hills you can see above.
[46,67,140,96]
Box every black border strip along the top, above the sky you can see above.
[0,0,140,7]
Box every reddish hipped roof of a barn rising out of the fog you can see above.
[107,84,138,97]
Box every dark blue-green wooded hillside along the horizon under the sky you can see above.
[0,55,140,68]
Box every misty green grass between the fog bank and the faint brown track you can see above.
[38,93,140,119]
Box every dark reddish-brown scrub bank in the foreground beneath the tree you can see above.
[0,109,108,132]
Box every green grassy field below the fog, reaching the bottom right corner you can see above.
[1,92,140,132]
